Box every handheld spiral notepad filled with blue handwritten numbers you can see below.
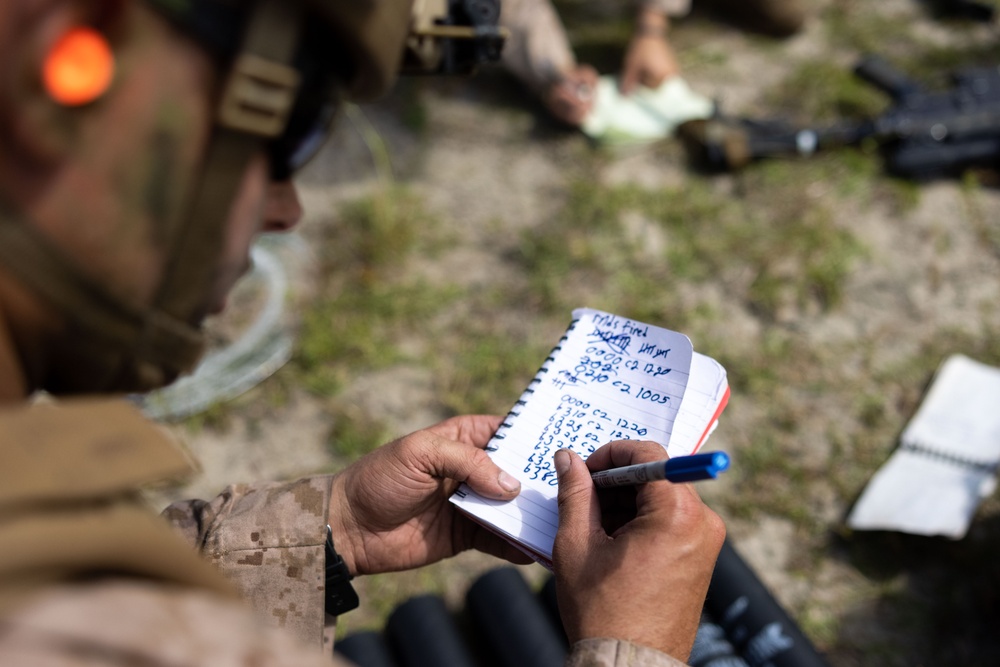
[452,308,729,565]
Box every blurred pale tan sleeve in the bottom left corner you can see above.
[0,580,354,667]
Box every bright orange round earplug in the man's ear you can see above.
[42,27,115,106]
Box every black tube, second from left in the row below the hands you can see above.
[385,595,476,667]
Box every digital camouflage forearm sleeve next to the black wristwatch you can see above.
[163,476,332,645]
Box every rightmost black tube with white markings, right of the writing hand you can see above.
[705,540,827,667]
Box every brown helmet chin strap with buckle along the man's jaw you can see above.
[0,0,301,394]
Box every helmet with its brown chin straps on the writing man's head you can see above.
[0,0,411,393]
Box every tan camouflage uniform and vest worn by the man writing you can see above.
[0,399,682,667]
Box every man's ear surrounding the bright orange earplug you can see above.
[6,0,129,165]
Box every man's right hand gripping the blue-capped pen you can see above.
[553,440,725,659]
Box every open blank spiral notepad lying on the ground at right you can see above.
[848,355,1000,539]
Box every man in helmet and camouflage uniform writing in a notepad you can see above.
[0,0,724,667]
